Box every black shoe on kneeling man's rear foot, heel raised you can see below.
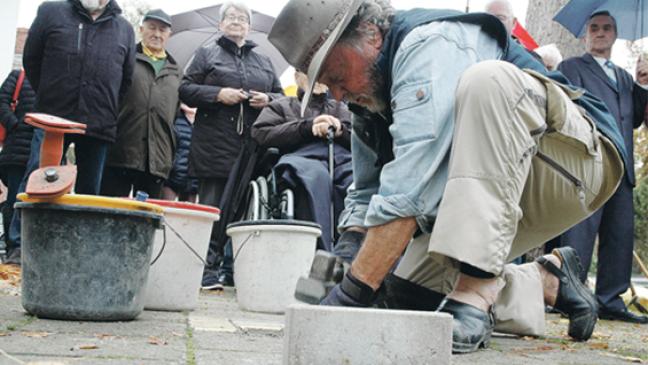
[536,247,598,341]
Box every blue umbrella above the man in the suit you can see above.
[554,0,648,41]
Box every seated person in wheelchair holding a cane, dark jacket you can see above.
[251,72,352,251]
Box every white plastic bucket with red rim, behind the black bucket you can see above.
[144,206,219,311]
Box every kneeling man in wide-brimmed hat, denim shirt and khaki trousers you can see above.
[269,0,627,352]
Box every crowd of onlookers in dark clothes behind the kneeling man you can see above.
[0,0,648,323]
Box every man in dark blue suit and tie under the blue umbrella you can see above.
[558,12,648,324]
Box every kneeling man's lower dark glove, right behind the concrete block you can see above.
[320,270,377,307]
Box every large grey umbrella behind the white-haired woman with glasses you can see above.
[167,4,288,72]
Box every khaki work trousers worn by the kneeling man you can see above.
[395,61,623,335]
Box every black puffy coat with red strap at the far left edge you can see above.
[0,70,36,167]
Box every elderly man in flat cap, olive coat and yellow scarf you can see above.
[101,9,182,198]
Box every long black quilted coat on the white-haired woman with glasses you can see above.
[180,36,283,178]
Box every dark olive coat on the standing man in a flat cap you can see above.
[106,44,182,179]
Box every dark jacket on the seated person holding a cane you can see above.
[251,93,351,154]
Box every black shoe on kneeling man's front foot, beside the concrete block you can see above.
[439,298,495,354]
